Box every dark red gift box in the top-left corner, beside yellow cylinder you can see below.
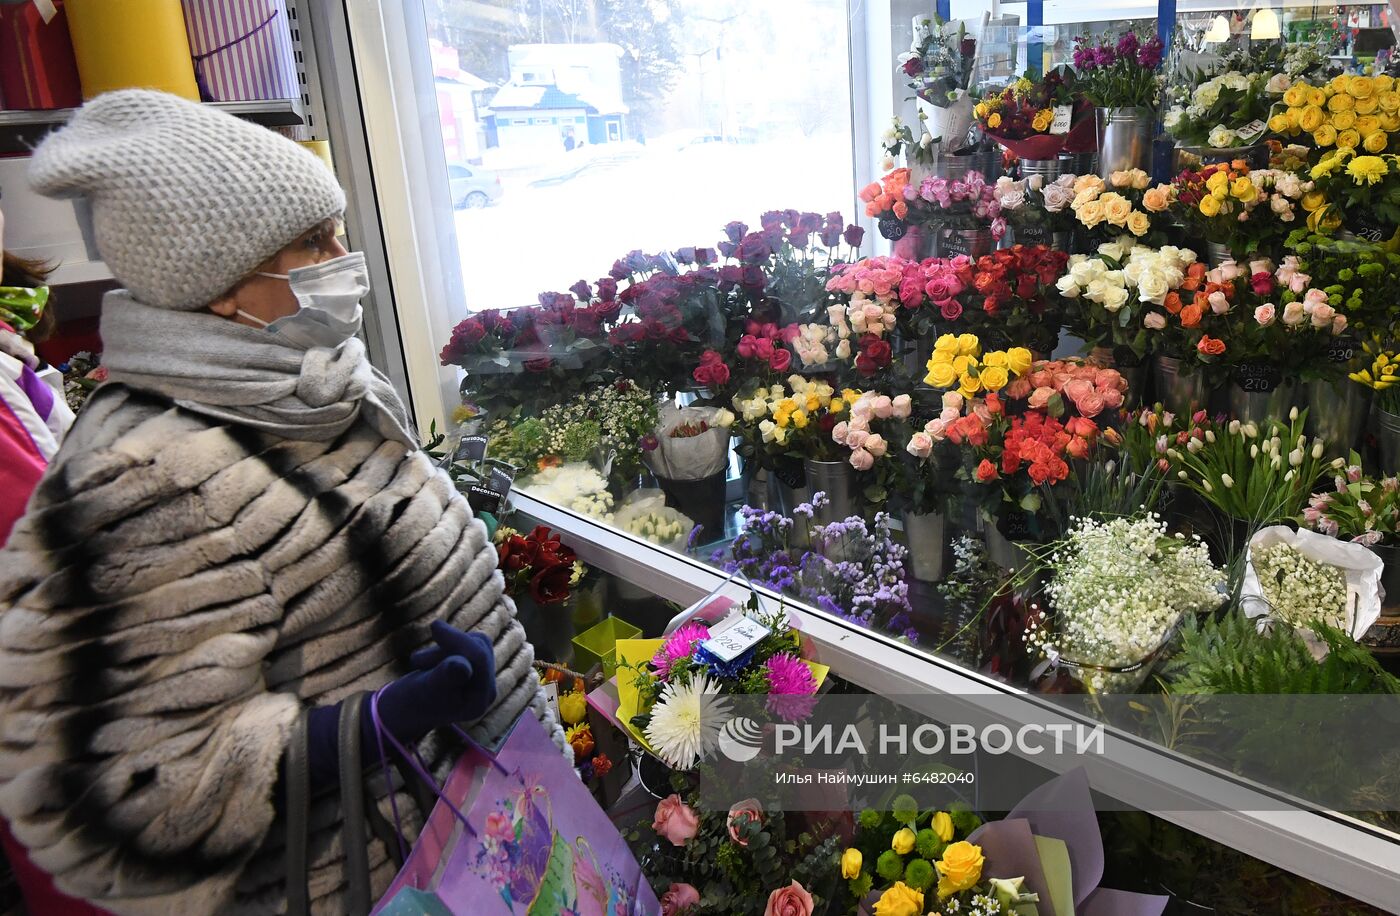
[0,0,83,111]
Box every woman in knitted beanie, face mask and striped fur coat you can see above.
[0,91,563,916]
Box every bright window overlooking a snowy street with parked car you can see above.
[424,0,854,316]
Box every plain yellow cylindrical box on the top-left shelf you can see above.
[63,0,199,102]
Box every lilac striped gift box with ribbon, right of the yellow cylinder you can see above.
[182,0,301,102]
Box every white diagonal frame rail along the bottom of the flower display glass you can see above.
[512,490,1400,912]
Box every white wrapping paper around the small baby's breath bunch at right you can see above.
[1240,525,1385,660]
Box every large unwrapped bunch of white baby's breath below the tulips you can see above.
[1026,514,1224,693]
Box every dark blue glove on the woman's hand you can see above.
[307,620,496,784]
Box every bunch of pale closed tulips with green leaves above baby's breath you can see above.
[1166,408,1345,525]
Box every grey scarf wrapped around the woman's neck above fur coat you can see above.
[102,290,419,448]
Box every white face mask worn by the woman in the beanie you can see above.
[238,251,370,350]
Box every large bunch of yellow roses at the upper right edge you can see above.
[1268,76,1400,155]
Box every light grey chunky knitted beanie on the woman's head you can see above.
[29,90,346,311]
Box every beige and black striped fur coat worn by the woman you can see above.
[0,385,564,915]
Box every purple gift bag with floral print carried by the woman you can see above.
[374,712,661,916]
